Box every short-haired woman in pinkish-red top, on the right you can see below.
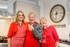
[40,17,59,47]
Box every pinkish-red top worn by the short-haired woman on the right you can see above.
[42,26,59,47]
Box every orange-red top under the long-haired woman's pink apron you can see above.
[8,22,26,38]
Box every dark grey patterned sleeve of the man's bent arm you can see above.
[32,24,42,40]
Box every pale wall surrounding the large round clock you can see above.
[44,0,70,39]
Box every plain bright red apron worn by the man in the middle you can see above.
[24,22,38,47]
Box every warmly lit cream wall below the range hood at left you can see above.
[0,18,12,36]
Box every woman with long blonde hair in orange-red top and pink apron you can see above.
[8,11,26,47]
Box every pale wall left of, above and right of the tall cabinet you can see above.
[8,0,43,16]
